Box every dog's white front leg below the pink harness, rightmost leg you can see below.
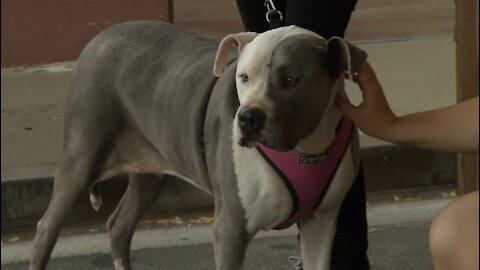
[299,213,337,270]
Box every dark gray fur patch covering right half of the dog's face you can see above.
[262,35,336,151]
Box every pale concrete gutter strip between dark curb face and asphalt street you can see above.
[2,198,452,265]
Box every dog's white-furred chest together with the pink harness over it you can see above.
[234,118,353,233]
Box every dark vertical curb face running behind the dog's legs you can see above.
[2,145,456,233]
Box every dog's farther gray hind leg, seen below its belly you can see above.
[107,173,167,270]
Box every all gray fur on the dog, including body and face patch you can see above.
[29,21,368,270]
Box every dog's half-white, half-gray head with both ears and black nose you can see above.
[214,26,367,151]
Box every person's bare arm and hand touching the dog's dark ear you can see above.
[337,63,479,152]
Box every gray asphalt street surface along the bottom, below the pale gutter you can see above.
[2,224,433,270]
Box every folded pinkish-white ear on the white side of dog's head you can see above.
[213,32,258,77]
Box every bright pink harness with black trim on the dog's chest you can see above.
[257,117,353,230]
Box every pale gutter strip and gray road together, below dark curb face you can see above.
[1,198,451,270]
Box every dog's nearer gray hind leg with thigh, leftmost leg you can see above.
[29,76,123,270]
